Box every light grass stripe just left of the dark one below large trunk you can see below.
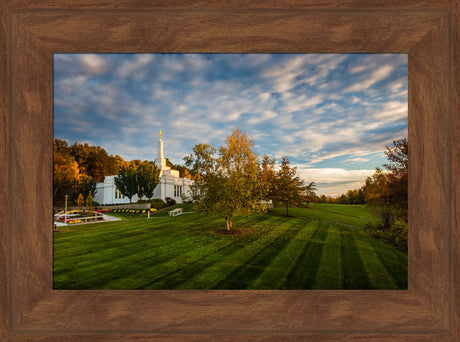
[172,217,294,289]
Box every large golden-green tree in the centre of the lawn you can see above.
[185,128,261,231]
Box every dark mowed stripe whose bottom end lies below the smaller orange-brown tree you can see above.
[283,221,328,289]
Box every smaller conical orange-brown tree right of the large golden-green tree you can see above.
[275,157,307,216]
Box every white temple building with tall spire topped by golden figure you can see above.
[94,130,193,205]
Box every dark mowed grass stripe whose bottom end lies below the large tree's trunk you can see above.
[214,220,305,289]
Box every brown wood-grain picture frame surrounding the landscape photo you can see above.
[0,0,460,341]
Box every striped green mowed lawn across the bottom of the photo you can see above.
[54,204,407,289]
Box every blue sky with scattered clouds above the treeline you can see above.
[54,54,407,196]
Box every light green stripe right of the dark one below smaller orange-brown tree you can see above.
[313,224,343,290]
